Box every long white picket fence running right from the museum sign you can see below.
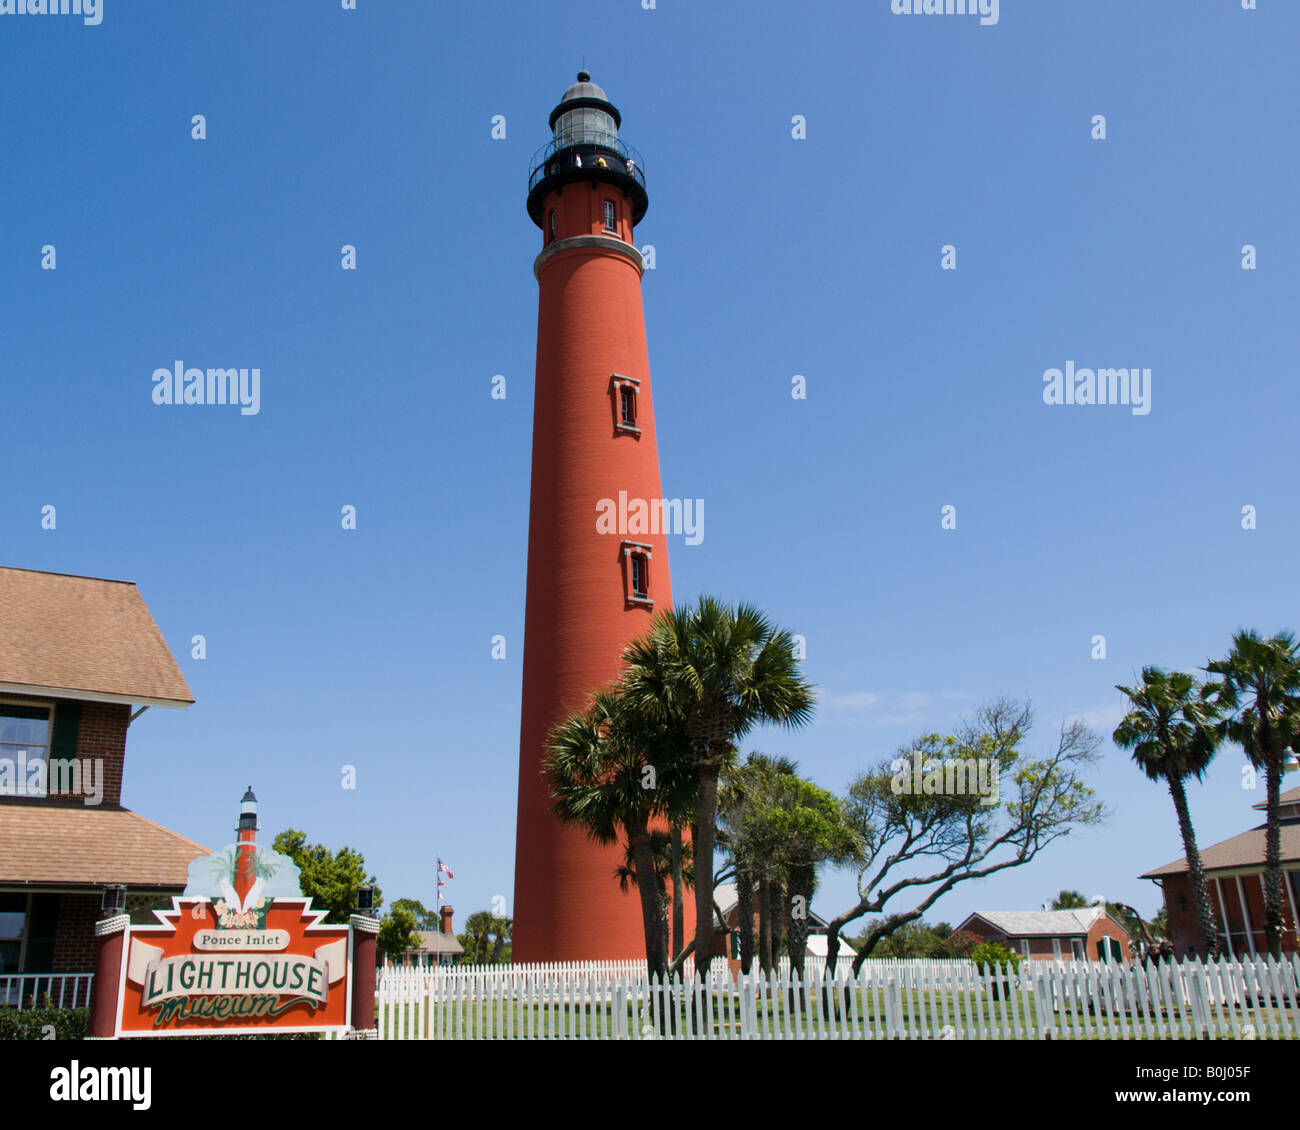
[366,956,1300,1040]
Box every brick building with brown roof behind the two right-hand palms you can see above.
[1141,788,1300,957]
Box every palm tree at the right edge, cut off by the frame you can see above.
[1205,631,1300,958]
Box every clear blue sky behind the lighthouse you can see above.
[0,0,1300,922]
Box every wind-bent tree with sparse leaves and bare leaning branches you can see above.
[827,700,1105,971]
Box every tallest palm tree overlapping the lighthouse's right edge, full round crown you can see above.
[623,597,813,977]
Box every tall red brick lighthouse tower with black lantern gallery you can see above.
[514,70,672,961]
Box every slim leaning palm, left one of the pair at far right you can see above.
[1113,667,1221,957]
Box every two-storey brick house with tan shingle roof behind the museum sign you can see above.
[0,568,209,1004]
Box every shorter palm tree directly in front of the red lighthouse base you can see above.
[545,689,668,975]
